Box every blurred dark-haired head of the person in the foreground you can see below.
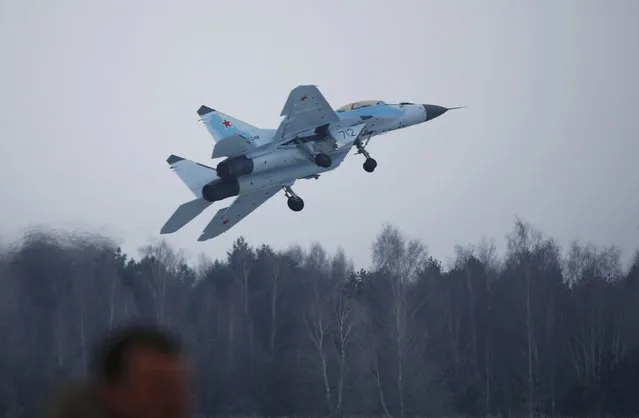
[94,325,190,418]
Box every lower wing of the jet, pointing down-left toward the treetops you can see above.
[197,185,282,241]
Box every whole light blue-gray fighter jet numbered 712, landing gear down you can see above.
[160,85,459,241]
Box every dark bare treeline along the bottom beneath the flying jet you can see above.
[0,221,639,418]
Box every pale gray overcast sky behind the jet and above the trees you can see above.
[0,0,639,265]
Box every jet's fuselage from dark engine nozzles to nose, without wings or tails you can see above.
[203,103,447,202]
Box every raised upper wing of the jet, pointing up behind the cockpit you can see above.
[275,85,340,142]
